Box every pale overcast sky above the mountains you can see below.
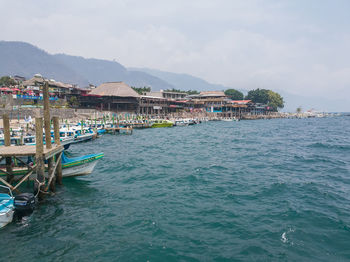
[0,0,350,108]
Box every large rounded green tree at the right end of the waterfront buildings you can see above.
[246,88,284,111]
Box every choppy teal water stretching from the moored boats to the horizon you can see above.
[0,117,350,261]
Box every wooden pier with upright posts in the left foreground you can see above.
[0,83,63,199]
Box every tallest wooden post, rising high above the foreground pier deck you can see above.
[43,82,55,192]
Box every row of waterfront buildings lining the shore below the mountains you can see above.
[0,74,271,118]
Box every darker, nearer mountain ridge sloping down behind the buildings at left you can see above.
[0,41,174,90]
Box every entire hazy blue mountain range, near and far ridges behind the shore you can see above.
[0,41,346,111]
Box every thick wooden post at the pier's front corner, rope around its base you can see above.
[35,117,45,199]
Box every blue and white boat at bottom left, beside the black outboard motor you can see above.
[0,185,14,228]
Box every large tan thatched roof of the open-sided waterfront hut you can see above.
[90,82,140,98]
